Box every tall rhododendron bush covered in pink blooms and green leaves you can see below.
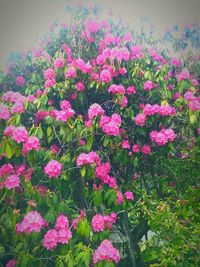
[0,3,200,267]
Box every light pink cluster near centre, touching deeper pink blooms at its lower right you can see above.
[76,151,100,166]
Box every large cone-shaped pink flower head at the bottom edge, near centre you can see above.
[93,239,120,264]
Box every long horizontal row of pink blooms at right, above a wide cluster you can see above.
[143,104,176,116]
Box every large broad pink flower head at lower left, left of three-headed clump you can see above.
[16,211,48,233]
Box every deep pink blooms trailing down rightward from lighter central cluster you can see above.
[95,162,117,188]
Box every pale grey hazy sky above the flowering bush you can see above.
[0,0,200,67]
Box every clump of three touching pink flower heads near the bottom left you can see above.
[42,215,72,250]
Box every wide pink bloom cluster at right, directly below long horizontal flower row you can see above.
[150,129,175,146]
